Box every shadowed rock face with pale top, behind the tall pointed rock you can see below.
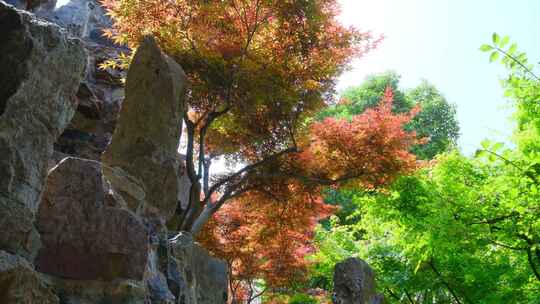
[28,0,129,160]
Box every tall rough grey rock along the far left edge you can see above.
[0,1,86,258]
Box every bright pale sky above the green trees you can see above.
[339,0,540,154]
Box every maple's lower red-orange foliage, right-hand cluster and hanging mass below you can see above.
[198,89,418,303]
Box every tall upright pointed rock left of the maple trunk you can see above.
[102,37,186,223]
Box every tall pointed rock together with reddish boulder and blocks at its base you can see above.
[32,38,227,304]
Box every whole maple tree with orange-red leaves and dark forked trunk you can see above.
[102,0,417,302]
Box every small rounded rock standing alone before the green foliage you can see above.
[332,258,384,304]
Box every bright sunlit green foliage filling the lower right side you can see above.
[311,34,540,304]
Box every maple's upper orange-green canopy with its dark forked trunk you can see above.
[102,0,399,233]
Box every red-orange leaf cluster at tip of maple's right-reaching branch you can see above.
[297,88,422,187]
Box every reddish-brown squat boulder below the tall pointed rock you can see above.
[36,158,148,281]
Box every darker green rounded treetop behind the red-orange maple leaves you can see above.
[317,72,459,159]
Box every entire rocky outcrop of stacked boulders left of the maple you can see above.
[0,0,228,304]
